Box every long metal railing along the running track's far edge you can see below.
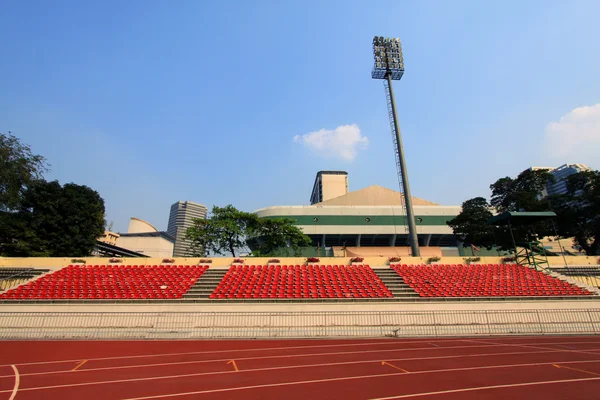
[0,309,600,339]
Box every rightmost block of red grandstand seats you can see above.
[391,264,592,297]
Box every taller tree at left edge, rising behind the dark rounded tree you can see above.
[0,132,48,212]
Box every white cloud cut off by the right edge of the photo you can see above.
[545,104,600,168]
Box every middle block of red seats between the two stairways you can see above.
[209,265,393,299]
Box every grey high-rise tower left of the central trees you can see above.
[167,201,208,257]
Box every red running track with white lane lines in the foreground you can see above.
[0,336,600,400]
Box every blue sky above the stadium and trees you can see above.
[0,0,600,231]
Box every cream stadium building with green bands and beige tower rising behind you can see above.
[255,171,461,256]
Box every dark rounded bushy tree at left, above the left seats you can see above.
[1,180,104,257]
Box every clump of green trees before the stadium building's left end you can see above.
[186,204,311,257]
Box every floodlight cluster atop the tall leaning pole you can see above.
[371,36,404,80]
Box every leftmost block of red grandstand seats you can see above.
[0,265,208,300]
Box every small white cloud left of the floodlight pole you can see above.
[294,124,369,161]
